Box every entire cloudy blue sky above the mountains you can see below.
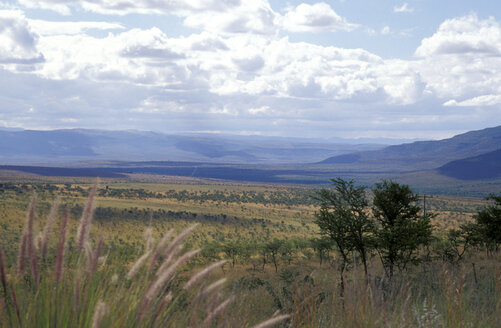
[0,0,501,139]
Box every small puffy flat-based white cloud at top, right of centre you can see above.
[280,2,357,32]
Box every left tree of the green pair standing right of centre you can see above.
[315,178,374,290]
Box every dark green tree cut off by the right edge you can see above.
[475,195,501,251]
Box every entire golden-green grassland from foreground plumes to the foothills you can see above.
[0,176,501,327]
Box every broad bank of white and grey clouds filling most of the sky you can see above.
[0,6,501,136]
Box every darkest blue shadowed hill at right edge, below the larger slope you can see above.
[438,149,501,180]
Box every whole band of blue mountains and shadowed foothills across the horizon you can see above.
[0,126,501,183]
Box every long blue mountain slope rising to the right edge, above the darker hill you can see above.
[318,126,501,172]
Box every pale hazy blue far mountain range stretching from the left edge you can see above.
[0,129,385,164]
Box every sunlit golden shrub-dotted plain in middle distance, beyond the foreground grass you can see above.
[0,177,486,252]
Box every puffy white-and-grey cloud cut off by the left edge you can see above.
[0,10,43,65]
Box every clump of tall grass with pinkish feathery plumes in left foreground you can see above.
[0,185,292,328]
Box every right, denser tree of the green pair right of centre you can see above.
[372,180,433,279]
